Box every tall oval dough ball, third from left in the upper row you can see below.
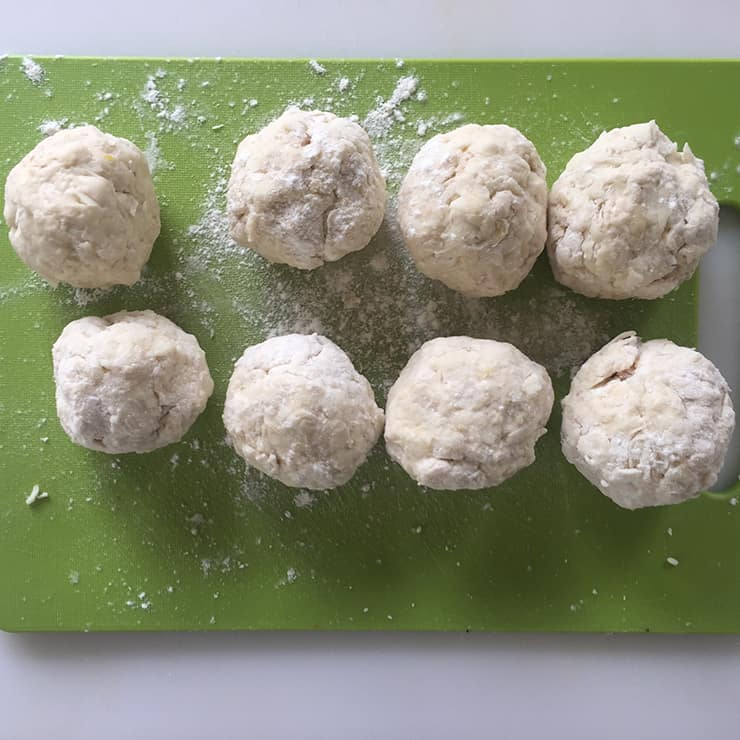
[398,124,547,296]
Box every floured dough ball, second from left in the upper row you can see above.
[227,109,385,270]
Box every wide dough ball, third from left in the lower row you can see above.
[385,337,553,490]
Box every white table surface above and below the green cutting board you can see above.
[0,0,740,740]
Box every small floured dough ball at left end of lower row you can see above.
[52,311,213,454]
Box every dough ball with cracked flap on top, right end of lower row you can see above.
[561,332,735,509]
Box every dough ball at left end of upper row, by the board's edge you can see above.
[4,126,159,288]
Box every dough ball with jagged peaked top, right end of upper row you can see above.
[548,121,719,298]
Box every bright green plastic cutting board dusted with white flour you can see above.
[0,58,740,632]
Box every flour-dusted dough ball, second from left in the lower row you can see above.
[224,334,383,490]
